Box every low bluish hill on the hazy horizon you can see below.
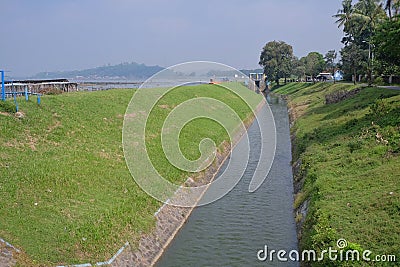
[31,62,164,80]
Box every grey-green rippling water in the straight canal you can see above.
[157,99,298,267]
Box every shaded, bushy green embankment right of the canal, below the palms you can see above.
[275,83,400,266]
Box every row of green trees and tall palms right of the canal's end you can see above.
[259,0,400,85]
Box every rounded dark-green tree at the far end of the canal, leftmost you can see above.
[259,41,293,85]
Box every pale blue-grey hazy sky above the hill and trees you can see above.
[0,0,342,77]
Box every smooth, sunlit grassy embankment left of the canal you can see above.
[0,85,261,266]
